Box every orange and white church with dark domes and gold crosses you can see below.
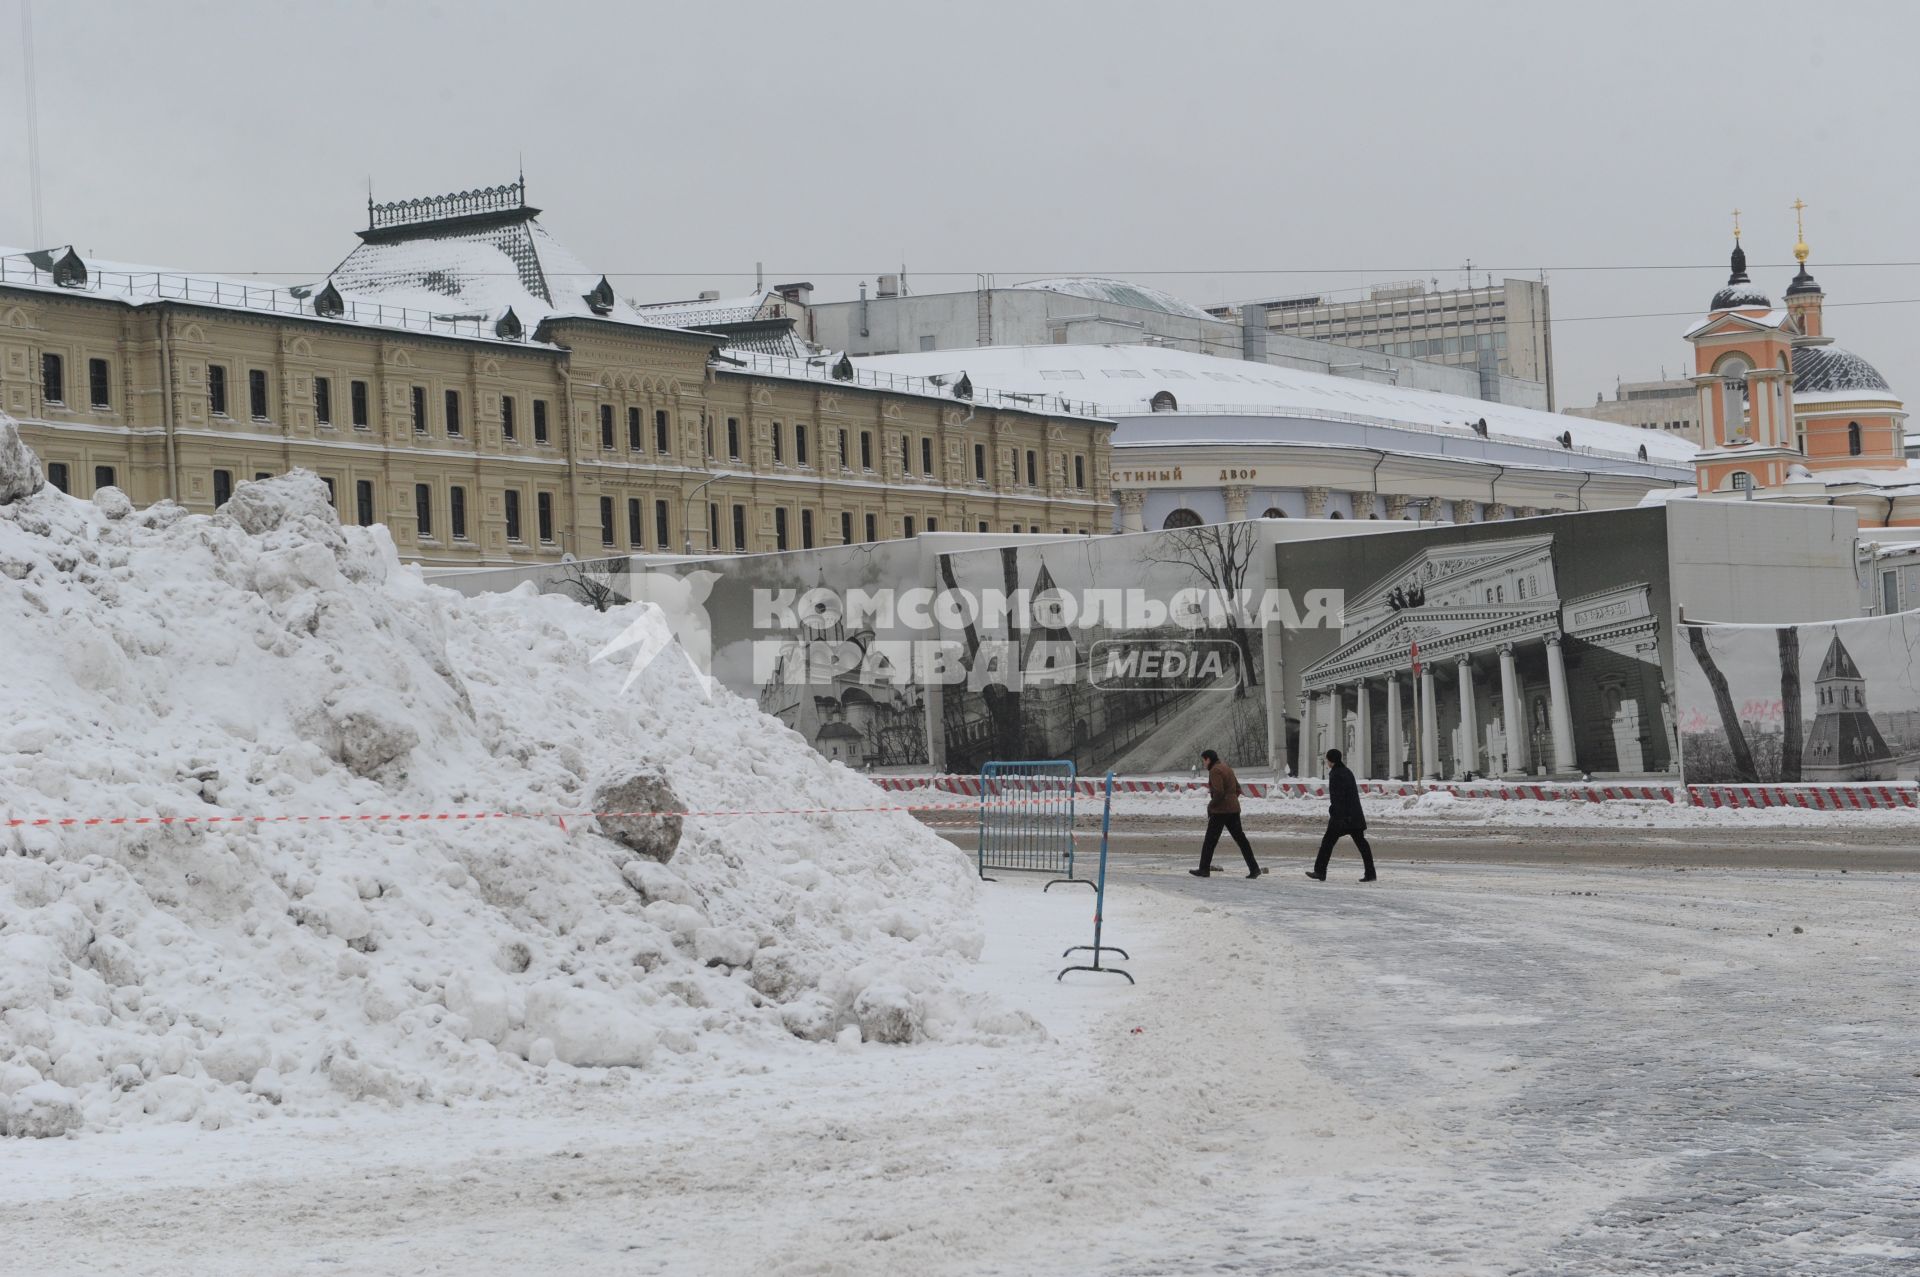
[1686,200,1920,514]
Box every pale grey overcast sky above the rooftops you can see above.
[0,0,1920,405]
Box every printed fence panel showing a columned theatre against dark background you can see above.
[1275,509,1678,780]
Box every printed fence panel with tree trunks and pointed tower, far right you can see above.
[1678,613,1920,785]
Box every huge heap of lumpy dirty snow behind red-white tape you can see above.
[0,417,1037,1135]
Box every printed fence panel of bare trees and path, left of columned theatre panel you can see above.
[939,522,1267,774]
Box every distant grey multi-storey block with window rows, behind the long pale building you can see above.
[1210,278,1553,411]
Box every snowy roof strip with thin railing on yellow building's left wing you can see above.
[0,253,526,342]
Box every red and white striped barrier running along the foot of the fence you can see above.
[874,776,1920,812]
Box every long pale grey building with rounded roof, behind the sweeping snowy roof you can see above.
[802,275,1548,409]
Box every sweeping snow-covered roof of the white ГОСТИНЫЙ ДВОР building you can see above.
[856,344,1697,465]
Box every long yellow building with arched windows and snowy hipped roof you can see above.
[0,184,1114,566]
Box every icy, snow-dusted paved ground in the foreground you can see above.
[0,855,1920,1277]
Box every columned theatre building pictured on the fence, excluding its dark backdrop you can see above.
[1300,534,1674,778]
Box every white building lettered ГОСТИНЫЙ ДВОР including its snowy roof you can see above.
[854,344,1695,532]
